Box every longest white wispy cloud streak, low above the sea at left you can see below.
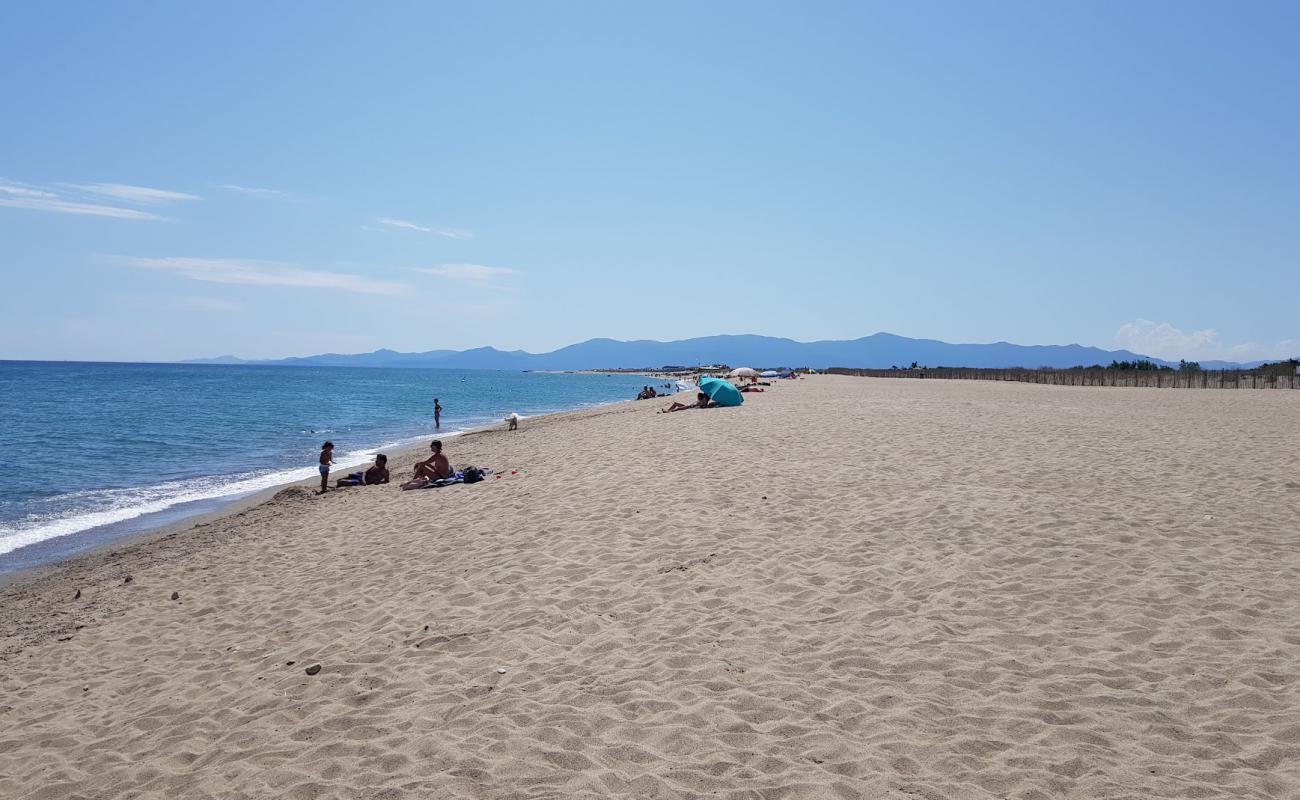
[118,256,410,294]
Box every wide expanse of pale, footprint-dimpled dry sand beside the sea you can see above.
[0,376,1300,800]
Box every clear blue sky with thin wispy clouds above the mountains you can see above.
[0,0,1300,360]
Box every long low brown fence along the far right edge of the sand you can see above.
[826,367,1300,389]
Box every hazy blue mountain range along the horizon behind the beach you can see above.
[185,333,1261,369]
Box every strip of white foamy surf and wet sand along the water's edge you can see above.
[0,399,665,591]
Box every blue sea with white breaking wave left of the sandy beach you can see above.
[0,362,662,575]
